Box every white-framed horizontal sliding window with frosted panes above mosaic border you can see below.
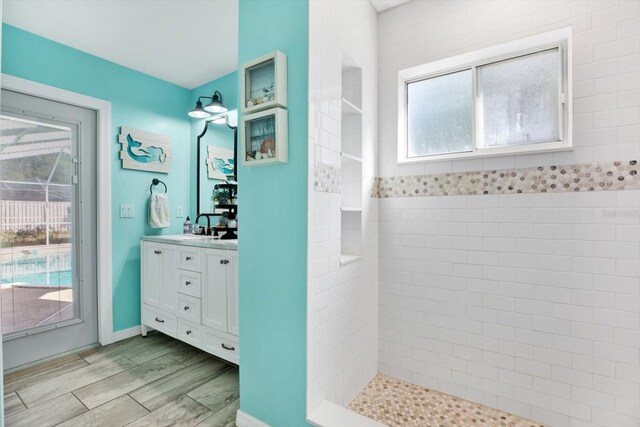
[398,29,572,163]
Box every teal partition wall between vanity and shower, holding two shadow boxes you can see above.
[238,0,309,427]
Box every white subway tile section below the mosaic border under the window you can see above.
[380,191,640,427]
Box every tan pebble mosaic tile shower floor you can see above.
[349,374,544,427]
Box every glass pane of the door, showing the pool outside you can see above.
[0,115,78,338]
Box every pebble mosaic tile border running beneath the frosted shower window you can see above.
[378,160,640,198]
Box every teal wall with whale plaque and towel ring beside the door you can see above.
[2,24,193,331]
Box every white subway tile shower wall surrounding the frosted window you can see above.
[378,0,640,427]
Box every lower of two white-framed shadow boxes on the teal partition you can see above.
[240,108,289,166]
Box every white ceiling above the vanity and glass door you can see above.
[2,0,238,89]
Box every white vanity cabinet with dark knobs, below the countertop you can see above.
[141,238,239,364]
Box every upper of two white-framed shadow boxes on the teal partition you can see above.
[240,51,287,114]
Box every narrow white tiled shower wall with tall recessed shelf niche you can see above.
[307,0,378,412]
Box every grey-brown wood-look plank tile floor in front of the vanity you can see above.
[4,332,240,427]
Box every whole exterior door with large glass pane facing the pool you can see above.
[0,90,97,368]
